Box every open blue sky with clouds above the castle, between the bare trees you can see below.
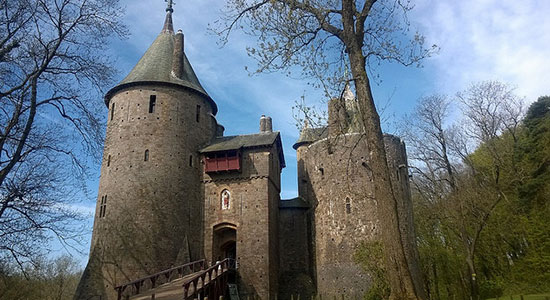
[62,0,550,264]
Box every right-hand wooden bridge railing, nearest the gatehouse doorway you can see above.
[182,258,236,299]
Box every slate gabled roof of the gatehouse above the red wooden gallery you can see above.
[203,131,286,168]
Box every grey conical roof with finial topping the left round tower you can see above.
[105,10,218,114]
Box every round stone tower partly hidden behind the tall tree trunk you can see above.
[294,86,418,298]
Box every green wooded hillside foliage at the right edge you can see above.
[413,91,550,299]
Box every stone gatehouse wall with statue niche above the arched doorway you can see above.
[203,147,281,299]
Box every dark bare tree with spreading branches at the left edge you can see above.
[0,0,126,270]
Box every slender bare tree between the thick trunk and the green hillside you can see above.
[400,95,461,299]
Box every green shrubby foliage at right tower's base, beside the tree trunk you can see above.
[354,242,390,300]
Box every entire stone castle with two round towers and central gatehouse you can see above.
[75,6,414,299]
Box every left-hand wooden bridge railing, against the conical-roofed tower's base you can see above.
[115,259,207,300]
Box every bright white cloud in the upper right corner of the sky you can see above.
[411,0,550,102]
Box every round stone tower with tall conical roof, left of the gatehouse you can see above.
[75,5,221,299]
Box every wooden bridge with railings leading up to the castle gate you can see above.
[115,258,235,300]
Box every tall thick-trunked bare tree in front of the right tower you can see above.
[219,0,438,299]
